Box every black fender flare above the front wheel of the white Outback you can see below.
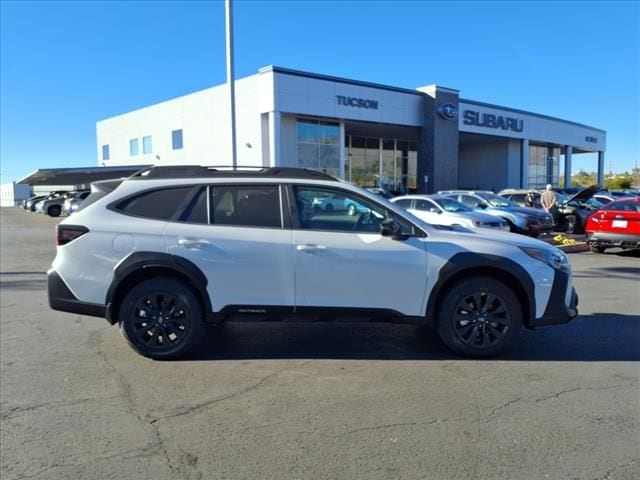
[426,252,536,325]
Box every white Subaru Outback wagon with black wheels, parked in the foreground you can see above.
[48,166,578,359]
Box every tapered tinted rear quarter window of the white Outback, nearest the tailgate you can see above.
[115,186,193,220]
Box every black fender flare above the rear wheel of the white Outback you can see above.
[105,252,212,325]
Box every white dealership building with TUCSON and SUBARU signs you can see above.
[96,66,607,193]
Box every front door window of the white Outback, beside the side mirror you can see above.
[294,187,389,233]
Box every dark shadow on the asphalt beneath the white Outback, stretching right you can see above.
[185,313,640,362]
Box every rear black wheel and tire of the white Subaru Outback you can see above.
[118,277,204,360]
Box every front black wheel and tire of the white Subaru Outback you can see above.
[437,277,522,358]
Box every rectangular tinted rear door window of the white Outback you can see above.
[210,185,282,228]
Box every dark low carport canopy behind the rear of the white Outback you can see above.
[17,165,151,185]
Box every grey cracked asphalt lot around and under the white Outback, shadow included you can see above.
[0,208,640,480]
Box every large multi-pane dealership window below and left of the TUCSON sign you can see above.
[297,120,340,177]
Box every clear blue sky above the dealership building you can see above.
[0,0,640,183]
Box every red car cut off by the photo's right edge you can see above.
[585,197,640,253]
